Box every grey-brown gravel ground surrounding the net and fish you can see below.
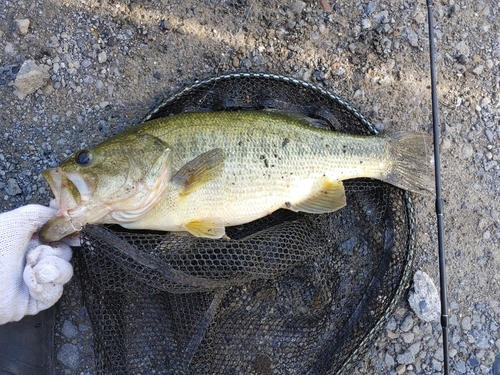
[0,0,500,374]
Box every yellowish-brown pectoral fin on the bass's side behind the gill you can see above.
[172,148,225,196]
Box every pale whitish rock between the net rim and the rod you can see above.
[408,271,441,322]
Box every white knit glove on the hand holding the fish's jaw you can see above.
[0,204,73,324]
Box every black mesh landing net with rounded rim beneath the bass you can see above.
[75,74,414,374]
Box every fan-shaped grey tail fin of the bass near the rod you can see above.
[384,131,434,194]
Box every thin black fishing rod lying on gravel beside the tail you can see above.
[427,0,450,375]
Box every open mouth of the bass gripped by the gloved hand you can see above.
[39,168,92,242]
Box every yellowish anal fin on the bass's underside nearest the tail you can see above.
[283,180,346,214]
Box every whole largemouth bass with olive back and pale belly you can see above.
[40,111,432,241]
